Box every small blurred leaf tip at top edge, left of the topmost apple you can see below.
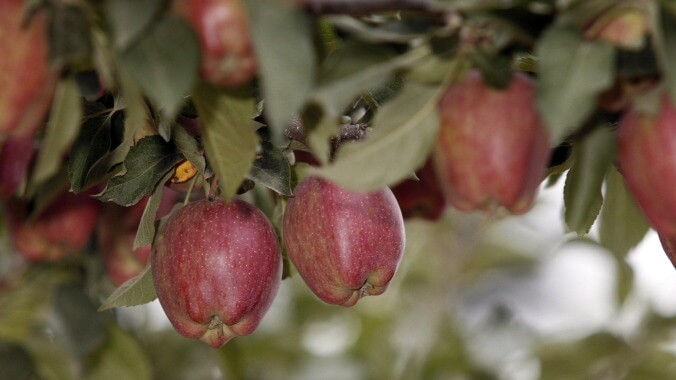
[105,0,163,50]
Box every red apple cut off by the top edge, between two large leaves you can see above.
[176,0,257,87]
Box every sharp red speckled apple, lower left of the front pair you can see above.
[150,199,282,347]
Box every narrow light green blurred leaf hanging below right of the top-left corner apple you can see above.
[31,78,83,187]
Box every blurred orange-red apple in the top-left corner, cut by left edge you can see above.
[0,0,57,142]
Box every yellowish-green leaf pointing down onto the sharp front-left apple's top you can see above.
[193,84,258,200]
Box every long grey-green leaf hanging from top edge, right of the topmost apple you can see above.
[244,0,316,136]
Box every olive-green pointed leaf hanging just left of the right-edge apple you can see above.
[599,169,650,260]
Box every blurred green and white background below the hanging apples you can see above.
[0,181,676,380]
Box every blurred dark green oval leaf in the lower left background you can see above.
[53,284,106,359]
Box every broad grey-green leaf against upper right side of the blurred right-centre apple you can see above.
[536,26,615,143]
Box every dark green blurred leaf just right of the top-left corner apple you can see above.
[47,3,92,68]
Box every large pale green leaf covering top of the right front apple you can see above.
[318,82,440,191]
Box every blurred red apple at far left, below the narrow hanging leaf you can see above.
[8,193,100,262]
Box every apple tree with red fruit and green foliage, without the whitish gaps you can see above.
[0,0,676,379]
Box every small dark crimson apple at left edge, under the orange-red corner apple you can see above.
[0,134,35,200]
